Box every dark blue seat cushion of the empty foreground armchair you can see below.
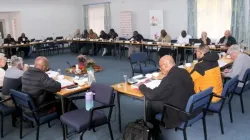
[61,108,108,132]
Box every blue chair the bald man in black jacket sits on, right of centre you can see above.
[156,87,213,140]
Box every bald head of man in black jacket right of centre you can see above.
[159,55,175,75]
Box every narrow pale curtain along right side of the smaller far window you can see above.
[104,3,111,33]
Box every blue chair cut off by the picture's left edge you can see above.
[0,88,16,138]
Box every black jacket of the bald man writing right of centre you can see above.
[139,67,195,128]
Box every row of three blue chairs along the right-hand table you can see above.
[156,69,250,140]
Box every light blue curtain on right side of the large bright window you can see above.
[231,0,246,42]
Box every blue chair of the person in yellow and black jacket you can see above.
[208,76,239,134]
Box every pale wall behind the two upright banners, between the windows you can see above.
[78,0,187,38]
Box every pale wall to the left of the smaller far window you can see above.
[0,0,82,39]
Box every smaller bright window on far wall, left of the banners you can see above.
[88,4,105,35]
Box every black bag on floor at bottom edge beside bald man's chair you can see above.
[123,119,153,140]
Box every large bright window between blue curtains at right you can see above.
[197,0,232,40]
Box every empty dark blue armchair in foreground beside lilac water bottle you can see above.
[61,83,115,140]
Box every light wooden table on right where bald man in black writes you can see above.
[112,56,233,132]
